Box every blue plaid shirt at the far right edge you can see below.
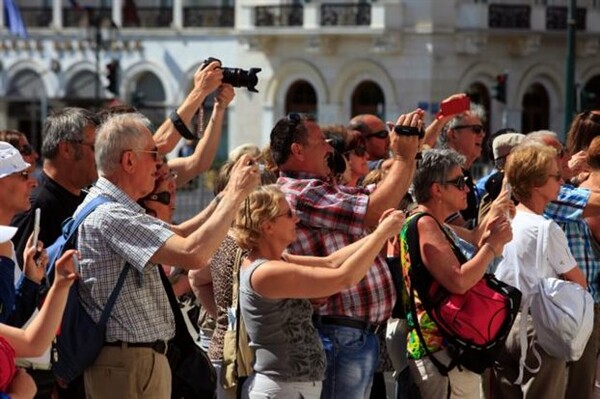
[544,185,600,303]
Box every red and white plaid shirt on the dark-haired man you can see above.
[277,172,396,324]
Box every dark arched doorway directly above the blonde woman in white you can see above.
[521,83,550,134]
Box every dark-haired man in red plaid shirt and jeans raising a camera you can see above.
[271,110,423,399]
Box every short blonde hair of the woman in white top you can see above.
[505,142,556,201]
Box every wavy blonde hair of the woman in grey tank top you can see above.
[234,184,285,251]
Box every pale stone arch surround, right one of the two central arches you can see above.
[331,59,399,123]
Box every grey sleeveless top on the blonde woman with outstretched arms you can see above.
[239,259,326,382]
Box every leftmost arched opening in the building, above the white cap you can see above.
[4,70,48,152]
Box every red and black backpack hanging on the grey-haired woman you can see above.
[401,213,521,375]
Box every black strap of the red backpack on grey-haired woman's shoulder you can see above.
[406,212,457,376]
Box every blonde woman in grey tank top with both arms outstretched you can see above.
[235,185,404,399]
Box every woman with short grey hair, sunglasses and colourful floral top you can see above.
[400,149,512,399]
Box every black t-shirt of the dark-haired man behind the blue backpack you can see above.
[11,172,85,267]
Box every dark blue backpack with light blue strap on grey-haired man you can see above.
[47,196,130,384]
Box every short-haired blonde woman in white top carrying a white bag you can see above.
[492,143,587,398]
